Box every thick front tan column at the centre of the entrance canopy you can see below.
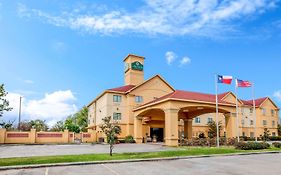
[165,109,179,146]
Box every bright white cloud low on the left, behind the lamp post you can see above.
[3,90,77,125]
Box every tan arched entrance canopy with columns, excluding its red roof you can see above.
[134,100,236,146]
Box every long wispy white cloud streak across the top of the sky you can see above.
[18,0,278,37]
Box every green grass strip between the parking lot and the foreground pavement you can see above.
[0,147,281,166]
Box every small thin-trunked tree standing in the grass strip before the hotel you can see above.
[100,116,121,156]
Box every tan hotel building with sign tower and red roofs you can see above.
[87,54,279,146]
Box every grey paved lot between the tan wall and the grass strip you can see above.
[0,144,176,158]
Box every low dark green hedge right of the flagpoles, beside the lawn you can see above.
[235,142,270,150]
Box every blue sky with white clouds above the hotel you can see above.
[0,0,281,124]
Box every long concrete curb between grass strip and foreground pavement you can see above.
[0,151,281,171]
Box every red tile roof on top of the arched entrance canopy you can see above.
[138,90,233,106]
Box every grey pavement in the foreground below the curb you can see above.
[0,154,281,175]
